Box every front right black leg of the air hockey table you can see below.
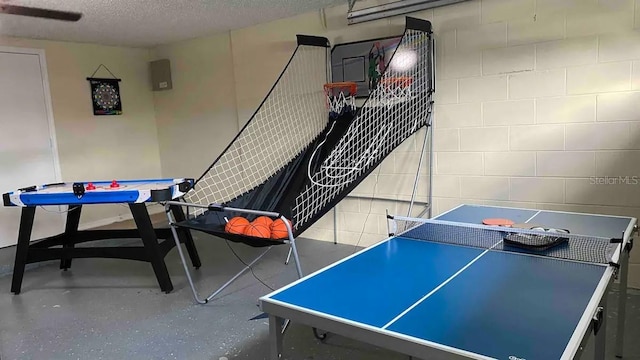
[129,203,173,293]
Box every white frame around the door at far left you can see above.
[0,46,62,186]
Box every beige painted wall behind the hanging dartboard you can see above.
[0,37,161,226]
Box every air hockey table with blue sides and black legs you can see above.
[2,179,200,294]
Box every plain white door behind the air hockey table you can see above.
[0,47,64,247]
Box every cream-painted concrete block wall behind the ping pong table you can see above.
[305,0,640,287]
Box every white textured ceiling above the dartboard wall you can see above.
[0,0,346,47]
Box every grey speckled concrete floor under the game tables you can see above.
[0,221,640,360]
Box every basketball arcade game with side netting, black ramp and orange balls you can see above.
[167,17,434,303]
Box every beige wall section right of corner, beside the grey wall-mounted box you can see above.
[151,33,239,178]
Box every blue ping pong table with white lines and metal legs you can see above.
[260,205,637,360]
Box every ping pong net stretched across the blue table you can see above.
[388,216,620,264]
